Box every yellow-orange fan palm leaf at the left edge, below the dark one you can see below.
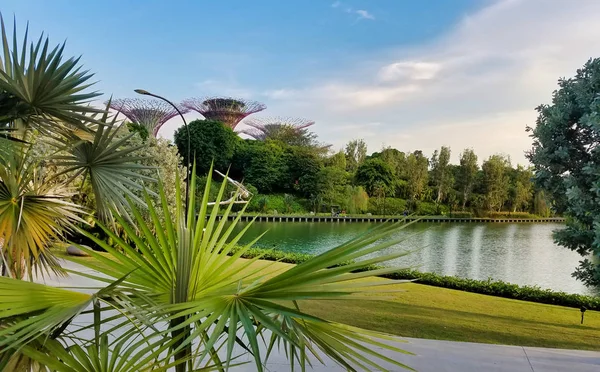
[0,150,85,278]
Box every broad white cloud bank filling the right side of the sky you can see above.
[264,0,600,163]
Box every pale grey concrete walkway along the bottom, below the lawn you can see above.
[233,338,600,372]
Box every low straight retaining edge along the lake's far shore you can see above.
[219,213,565,223]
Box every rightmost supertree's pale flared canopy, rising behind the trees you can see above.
[240,117,315,141]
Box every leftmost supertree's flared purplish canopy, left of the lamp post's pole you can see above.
[107,98,189,137]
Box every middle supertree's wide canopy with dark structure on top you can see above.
[182,97,267,129]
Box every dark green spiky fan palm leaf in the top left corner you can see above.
[0,14,103,137]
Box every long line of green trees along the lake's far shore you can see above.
[175,120,550,216]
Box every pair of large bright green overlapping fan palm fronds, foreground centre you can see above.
[56,166,414,370]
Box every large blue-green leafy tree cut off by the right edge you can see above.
[527,58,600,286]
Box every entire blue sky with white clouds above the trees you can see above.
[0,0,600,164]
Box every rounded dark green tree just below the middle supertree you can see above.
[173,120,240,176]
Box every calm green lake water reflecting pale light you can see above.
[231,222,600,295]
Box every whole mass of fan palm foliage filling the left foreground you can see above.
[0,13,418,372]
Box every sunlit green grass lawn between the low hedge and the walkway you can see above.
[54,248,600,350]
